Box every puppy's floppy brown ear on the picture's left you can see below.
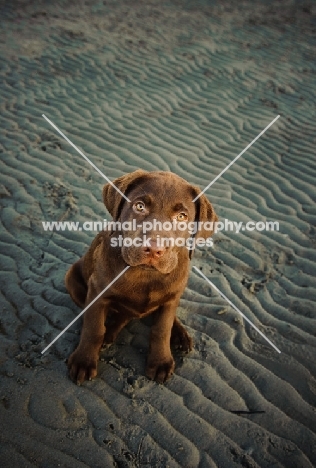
[103,169,147,220]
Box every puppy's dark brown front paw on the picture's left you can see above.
[67,348,98,385]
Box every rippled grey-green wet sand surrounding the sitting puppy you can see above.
[0,0,316,468]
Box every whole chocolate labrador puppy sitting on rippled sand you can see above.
[65,170,217,384]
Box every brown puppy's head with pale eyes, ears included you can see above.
[103,170,217,273]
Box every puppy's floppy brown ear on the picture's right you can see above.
[193,186,218,239]
